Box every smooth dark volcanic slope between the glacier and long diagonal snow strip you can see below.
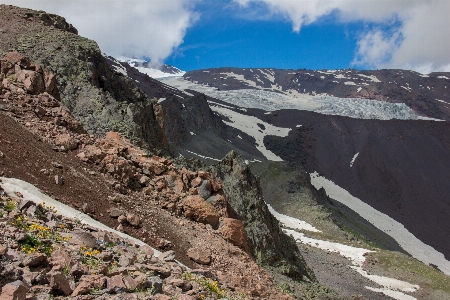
[259,110,450,259]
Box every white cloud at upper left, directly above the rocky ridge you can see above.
[0,0,198,62]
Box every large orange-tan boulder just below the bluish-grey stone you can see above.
[182,195,220,228]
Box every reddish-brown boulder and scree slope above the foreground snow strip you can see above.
[0,49,302,299]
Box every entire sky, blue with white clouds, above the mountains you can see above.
[0,0,450,74]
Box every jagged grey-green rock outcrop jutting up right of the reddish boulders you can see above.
[210,152,315,280]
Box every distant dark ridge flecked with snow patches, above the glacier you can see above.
[184,68,450,120]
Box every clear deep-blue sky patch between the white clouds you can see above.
[166,1,364,70]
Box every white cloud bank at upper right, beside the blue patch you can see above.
[233,0,450,73]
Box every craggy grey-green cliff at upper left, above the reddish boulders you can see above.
[0,5,168,151]
